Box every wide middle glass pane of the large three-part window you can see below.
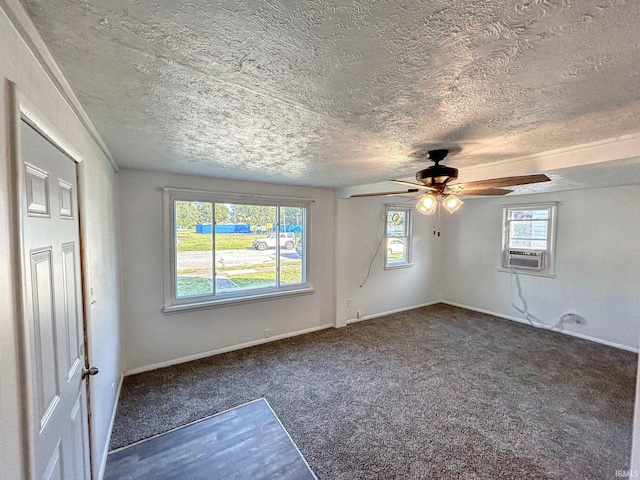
[214,204,282,293]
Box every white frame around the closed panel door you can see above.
[7,81,94,479]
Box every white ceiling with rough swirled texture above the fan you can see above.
[17,0,640,187]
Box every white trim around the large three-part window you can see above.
[162,187,314,313]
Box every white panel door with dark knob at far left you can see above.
[20,121,90,480]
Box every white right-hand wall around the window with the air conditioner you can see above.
[442,185,640,350]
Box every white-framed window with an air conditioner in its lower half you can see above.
[502,203,556,275]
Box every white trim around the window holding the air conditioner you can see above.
[498,202,558,278]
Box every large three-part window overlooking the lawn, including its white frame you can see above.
[164,189,311,311]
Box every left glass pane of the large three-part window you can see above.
[174,201,213,298]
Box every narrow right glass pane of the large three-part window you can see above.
[280,207,305,286]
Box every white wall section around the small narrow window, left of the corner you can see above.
[336,197,443,325]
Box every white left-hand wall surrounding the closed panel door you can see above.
[0,4,122,479]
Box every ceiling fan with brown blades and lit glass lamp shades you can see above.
[351,148,550,215]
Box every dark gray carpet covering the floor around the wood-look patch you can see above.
[111,305,637,480]
